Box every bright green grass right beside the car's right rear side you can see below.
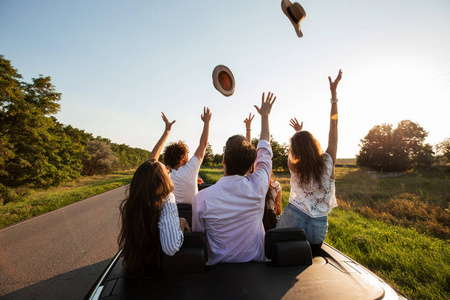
[325,209,450,299]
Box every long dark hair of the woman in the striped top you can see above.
[118,159,173,274]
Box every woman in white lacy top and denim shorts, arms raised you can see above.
[277,70,342,248]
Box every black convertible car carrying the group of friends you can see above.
[85,184,407,300]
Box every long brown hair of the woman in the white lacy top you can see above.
[289,131,325,187]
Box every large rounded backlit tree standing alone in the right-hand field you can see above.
[356,120,433,172]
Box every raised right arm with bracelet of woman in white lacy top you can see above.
[326,70,342,179]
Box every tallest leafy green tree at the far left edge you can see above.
[0,56,65,187]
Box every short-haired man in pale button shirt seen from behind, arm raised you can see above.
[192,93,276,265]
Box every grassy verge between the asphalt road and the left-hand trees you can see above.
[0,172,133,228]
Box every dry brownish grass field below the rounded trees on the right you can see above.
[336,168,450,240]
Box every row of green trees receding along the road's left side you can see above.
[0,55,149,203]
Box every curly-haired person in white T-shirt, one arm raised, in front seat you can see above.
[164,107,212,204]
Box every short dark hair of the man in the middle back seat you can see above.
[224,134,256,176]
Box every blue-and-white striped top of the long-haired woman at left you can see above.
[158,193,184,256]
